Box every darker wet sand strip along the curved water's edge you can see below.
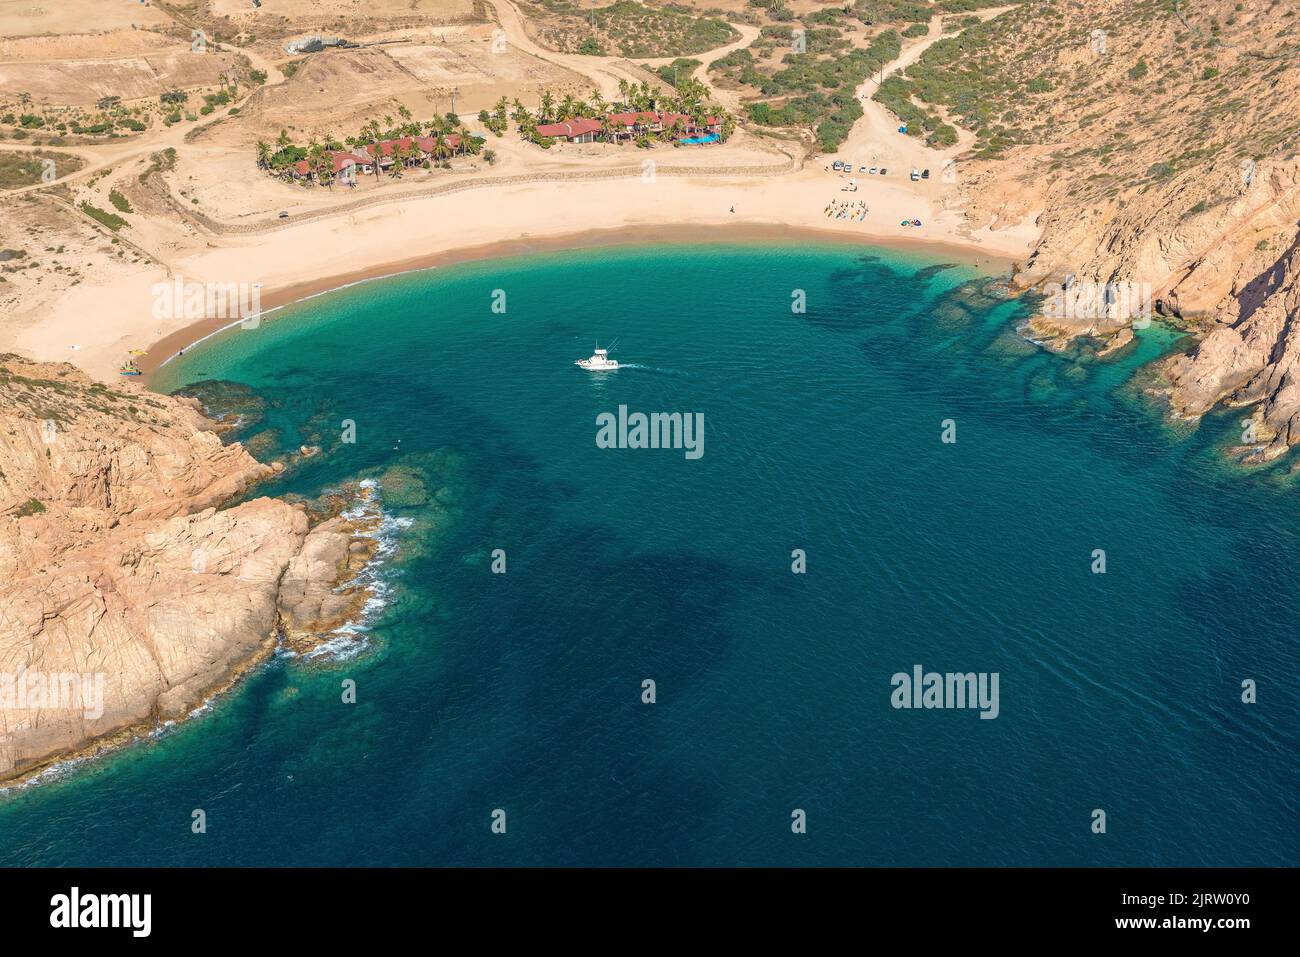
[138,222,1015,389]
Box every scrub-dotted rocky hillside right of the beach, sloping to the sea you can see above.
[876,0,1300,458]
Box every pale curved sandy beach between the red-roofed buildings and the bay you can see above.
[5,168,1034,378]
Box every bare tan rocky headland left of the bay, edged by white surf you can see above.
[0,356,372,779]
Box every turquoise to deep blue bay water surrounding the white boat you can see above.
[0,246,1300,865]
